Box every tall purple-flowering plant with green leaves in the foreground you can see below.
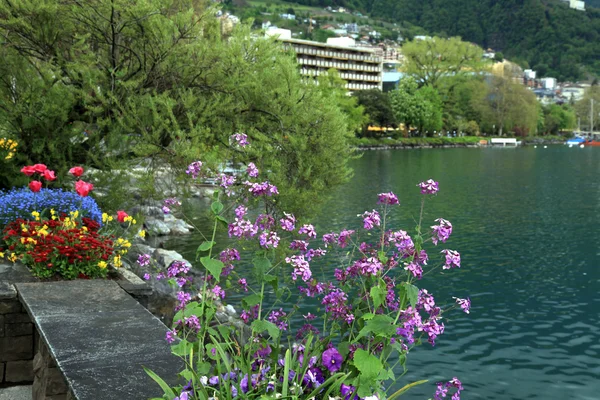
[146,137,470,400]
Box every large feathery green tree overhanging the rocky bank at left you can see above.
[0,0,353,217]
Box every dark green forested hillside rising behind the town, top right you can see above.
[295,0,600,80]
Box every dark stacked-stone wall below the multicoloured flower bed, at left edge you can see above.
[0,282,37,386]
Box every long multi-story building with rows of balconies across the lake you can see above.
[267,31,383,91]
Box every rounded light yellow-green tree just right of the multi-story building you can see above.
[402,37,485,88]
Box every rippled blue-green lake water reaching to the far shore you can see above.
[167,146,600,400]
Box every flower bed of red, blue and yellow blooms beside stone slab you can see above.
[0,164,143,279]
